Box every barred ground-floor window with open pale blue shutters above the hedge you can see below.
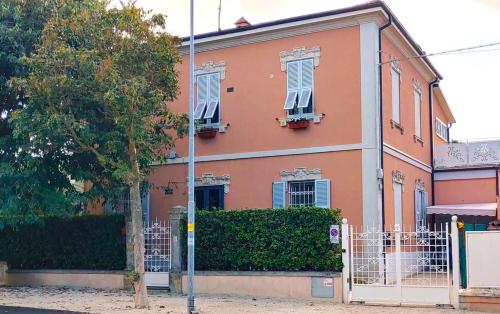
[273,179,330,208]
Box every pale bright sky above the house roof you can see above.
[131,0,500,140]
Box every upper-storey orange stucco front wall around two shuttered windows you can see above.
[166,27,361,156]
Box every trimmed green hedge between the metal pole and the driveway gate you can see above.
[180,208,342,271]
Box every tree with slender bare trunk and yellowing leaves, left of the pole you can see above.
[12,0,187,308]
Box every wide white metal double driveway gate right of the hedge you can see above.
[342,220,458,305]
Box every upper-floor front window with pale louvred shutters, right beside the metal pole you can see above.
[194,73,220,125]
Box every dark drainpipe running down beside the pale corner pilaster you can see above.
[378,14,392,227]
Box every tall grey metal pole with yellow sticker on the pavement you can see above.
[187,0,196,313]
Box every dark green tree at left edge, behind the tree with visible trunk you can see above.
[0,0,88,228]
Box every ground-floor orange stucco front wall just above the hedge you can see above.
[150,150,362,224]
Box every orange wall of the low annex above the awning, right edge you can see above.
[435,178,497,205]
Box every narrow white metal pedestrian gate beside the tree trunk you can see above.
[144,219,170,287]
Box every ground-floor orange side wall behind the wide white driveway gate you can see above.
[384,153,432,226]
